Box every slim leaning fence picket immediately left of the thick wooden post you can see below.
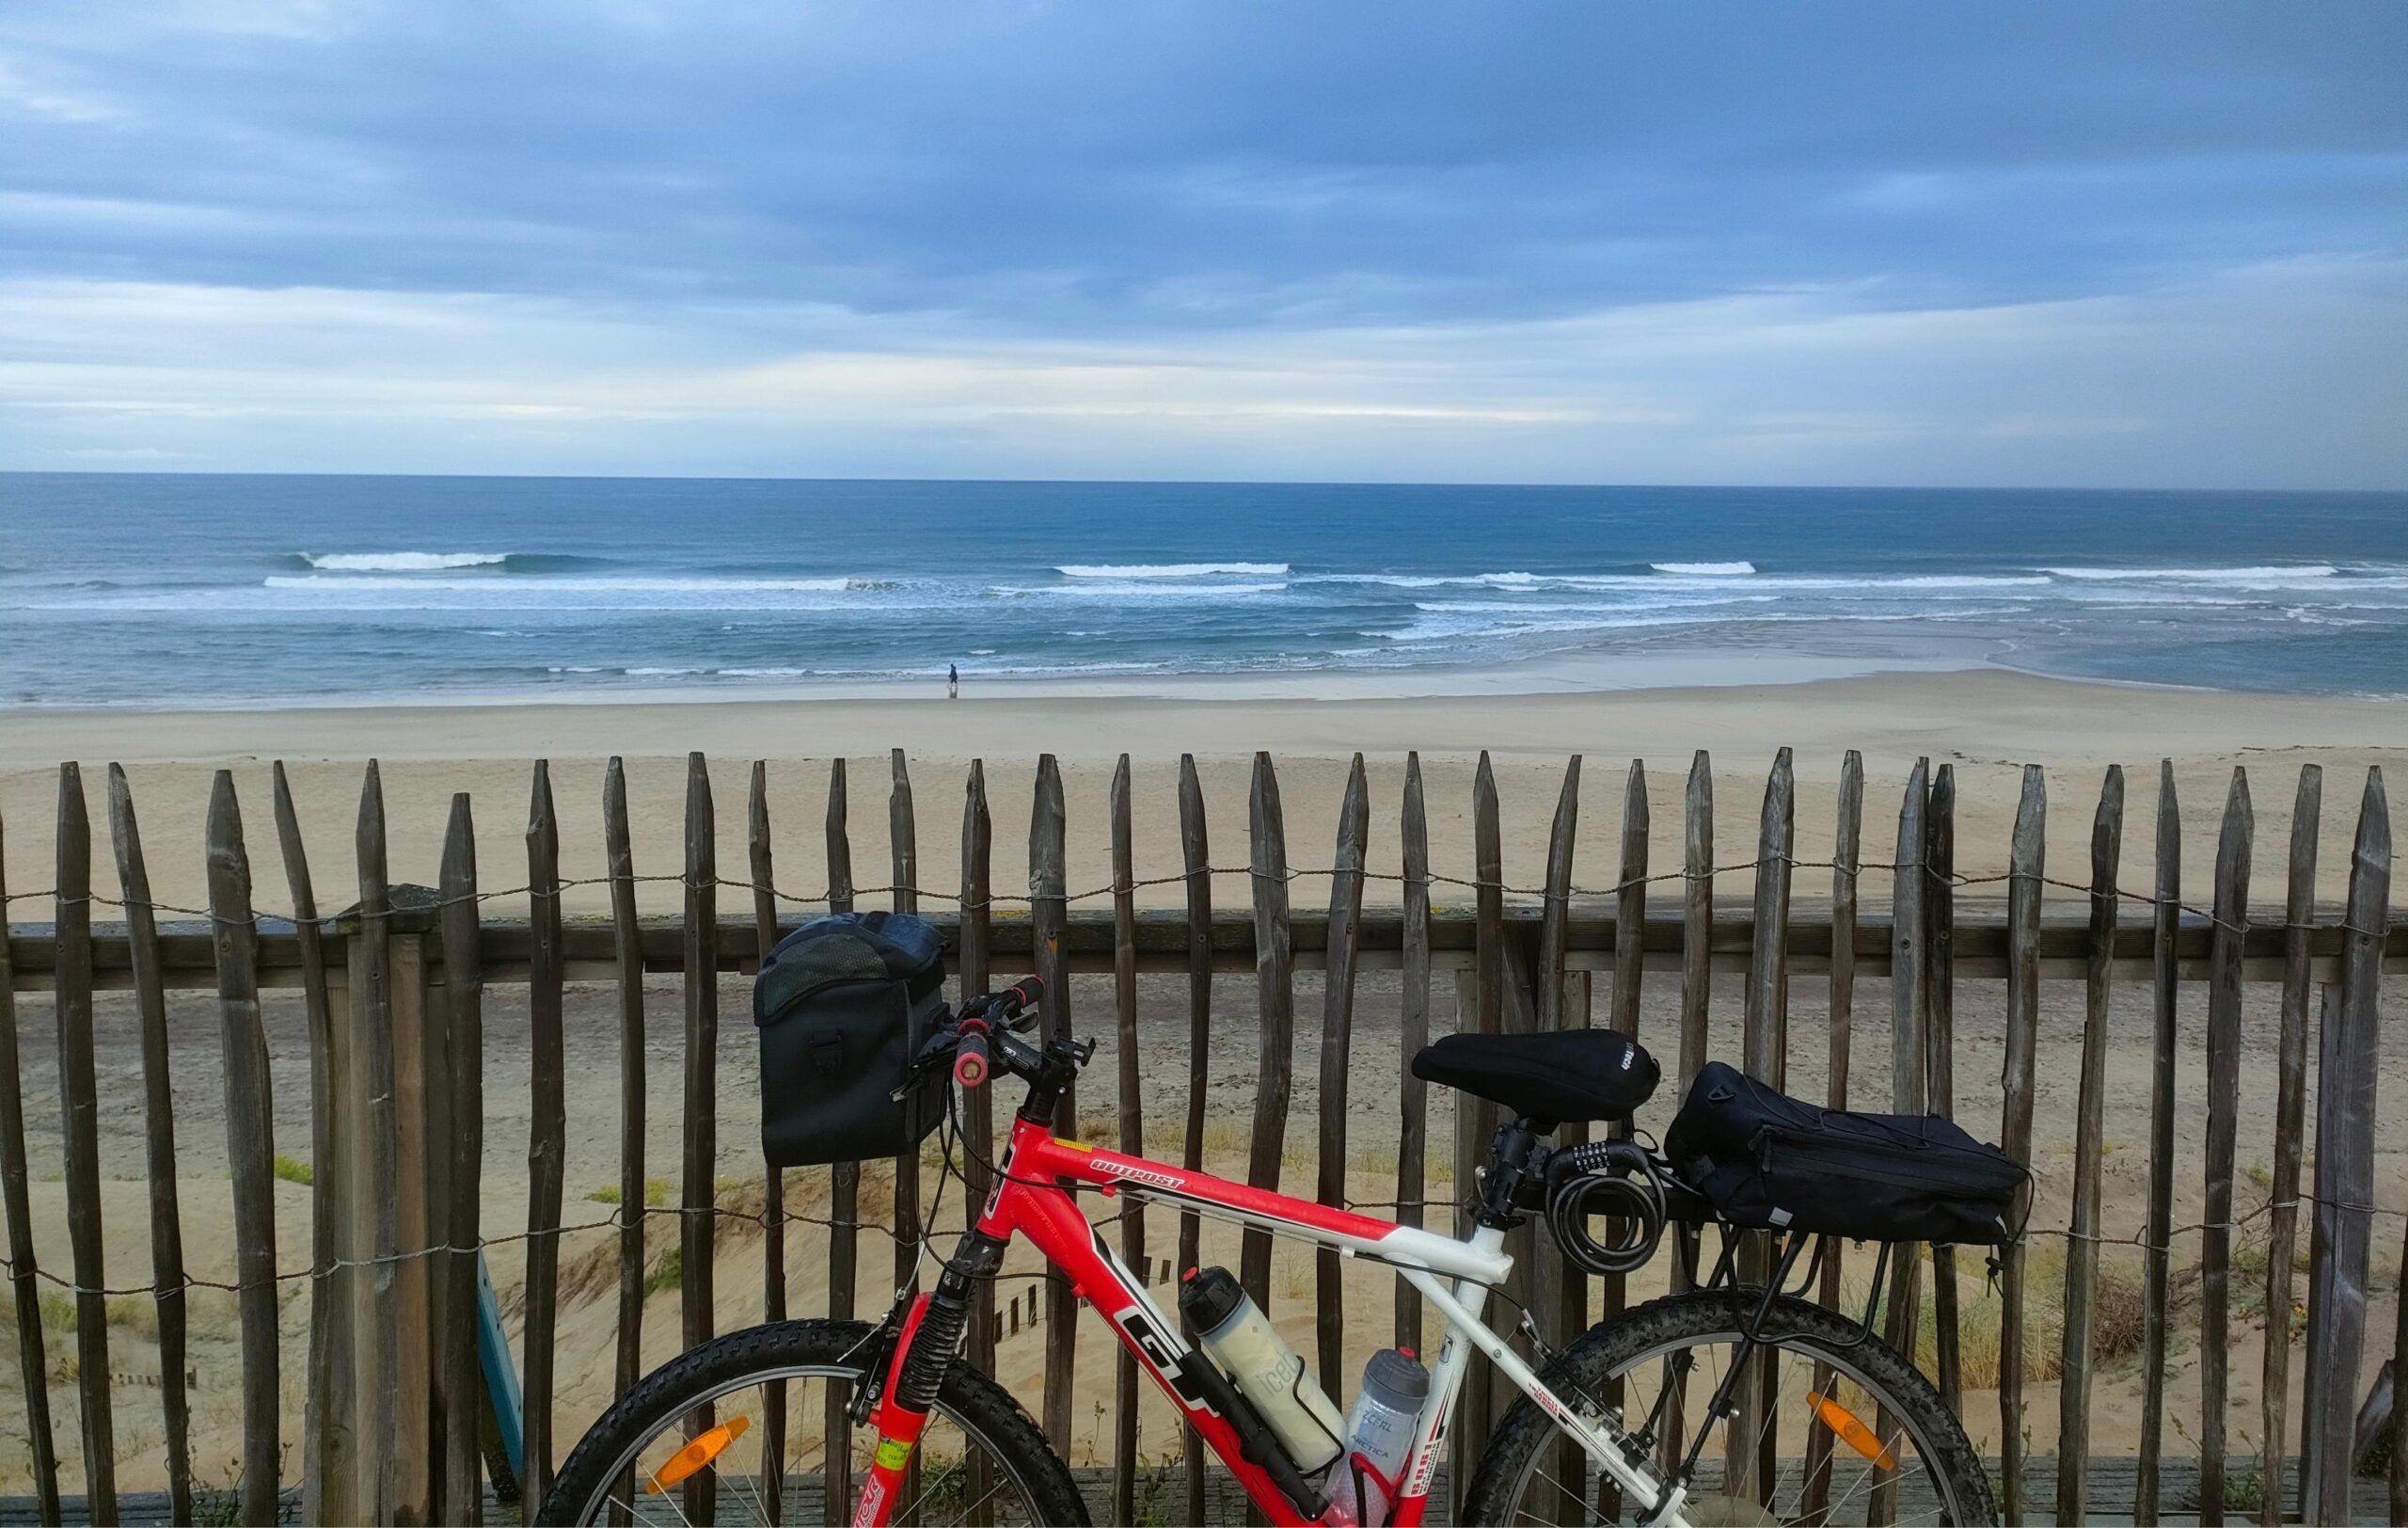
[272,759,339,1523]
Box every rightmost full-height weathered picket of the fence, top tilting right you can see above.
[2300,769,2391,1523]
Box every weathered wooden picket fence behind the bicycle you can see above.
[0,750,2408,1523]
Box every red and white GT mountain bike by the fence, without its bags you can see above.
[537,981,1996,1528]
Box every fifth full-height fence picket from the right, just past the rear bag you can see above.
[2056,764,2124,1519]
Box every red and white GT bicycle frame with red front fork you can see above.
[852,1116,1681,1528]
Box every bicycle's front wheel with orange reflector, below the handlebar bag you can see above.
[537,1321,1088,1528]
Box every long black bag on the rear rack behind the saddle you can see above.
[1664,1060,2025,1246]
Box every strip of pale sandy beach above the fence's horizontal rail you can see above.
[0,670,2408,918]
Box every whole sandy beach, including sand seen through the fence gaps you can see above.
[0,670,2408,1489]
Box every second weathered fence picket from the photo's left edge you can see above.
[51,764,118,1523]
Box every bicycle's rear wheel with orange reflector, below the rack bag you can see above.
[1464,1289,1999,1528]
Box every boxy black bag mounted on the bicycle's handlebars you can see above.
[753,914,946,1167]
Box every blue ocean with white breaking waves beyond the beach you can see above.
[0,475,2408,707]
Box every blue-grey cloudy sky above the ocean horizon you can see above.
[0,0,2408,489]
